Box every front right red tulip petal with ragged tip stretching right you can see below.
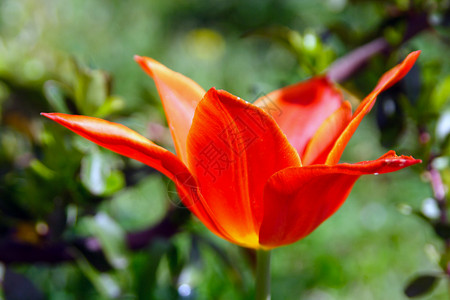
[260,151,421,248]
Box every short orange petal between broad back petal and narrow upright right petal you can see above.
[302,101,352,166]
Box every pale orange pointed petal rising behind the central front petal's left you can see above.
[135,56,205,164]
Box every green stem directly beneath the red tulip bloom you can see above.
[255,250,270,300]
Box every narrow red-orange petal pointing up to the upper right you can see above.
[326,51,420,165]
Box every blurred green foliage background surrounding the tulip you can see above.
[0,0,450,300]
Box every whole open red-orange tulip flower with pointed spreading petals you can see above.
[43,51,420,298]
